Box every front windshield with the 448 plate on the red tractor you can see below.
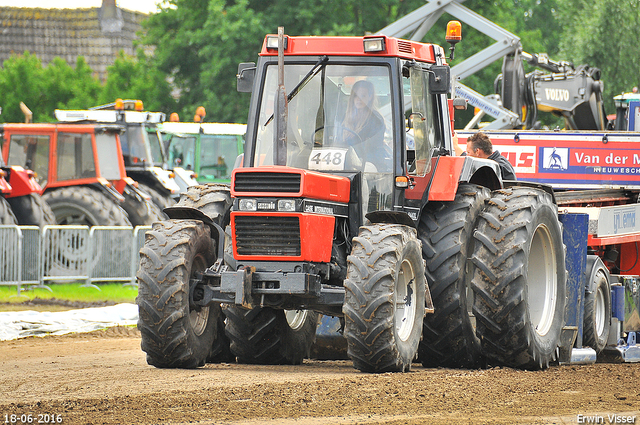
[253,64,393,212]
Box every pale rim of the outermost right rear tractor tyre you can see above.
[527,226,558,336]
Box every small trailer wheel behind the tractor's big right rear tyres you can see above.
[582,256,611,354]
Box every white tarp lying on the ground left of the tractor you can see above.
[0,304,138,341]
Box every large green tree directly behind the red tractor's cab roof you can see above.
[143,0,436,122]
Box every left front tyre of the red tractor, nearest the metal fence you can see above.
[136,220,221,369]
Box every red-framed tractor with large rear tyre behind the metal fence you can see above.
[0,124,165,226]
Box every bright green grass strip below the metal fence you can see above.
[0,283,138,304]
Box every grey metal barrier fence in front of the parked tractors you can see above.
[0,225,151,295]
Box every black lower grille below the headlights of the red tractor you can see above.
[235,216,301,257]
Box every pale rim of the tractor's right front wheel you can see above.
[394,255,416,341]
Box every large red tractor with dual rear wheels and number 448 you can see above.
[137,27,572,372]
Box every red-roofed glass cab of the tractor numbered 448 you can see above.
[238,36,452,224]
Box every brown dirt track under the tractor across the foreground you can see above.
[0,328,640,424]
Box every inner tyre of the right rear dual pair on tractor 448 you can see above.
[418,184,491,367]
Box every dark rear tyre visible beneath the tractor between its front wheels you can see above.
[223,306,318,365]
